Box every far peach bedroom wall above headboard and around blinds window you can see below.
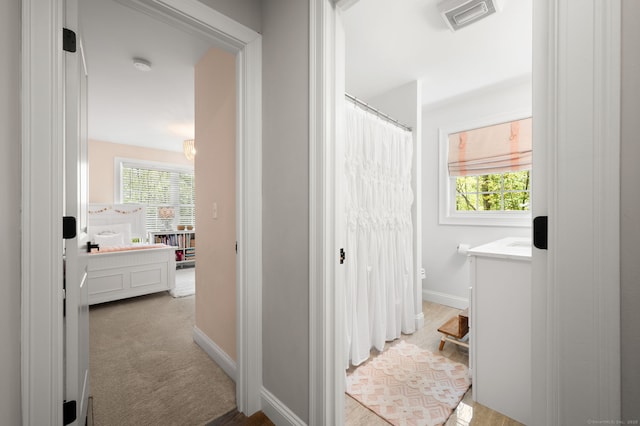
[89,140,193,204]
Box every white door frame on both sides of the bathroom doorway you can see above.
[309,0,620,426]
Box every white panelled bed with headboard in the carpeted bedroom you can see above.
[87,204,176,305]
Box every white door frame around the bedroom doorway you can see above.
[21,0,262,425]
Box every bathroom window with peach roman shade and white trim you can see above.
[440,113,532,226]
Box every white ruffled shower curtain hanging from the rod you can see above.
[345,102,415,365]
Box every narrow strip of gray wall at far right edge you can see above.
[620,0,640,421]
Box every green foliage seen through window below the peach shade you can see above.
[456,170,531,211]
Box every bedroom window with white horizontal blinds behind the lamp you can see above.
[119,161,196,232]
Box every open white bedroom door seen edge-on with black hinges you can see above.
[64,0,89,425]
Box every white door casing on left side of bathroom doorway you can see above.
[309,0,345,426]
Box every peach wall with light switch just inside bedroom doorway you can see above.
[195,48,236,360]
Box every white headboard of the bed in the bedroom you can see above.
[87,204,147,244]
